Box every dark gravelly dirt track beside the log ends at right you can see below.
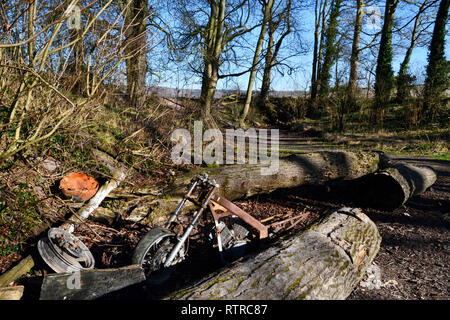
[349,157,450,300]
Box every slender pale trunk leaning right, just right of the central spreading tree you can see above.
[239,0,274,128]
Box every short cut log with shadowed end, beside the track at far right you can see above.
[358,163,437,210]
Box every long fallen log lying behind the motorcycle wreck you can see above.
[103,151,386,224]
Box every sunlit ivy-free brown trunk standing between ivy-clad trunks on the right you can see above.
[347,0,365,103]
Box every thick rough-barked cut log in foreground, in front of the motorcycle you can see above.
[166,208,381,300]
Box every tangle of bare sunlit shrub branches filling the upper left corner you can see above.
[0,0,159,163]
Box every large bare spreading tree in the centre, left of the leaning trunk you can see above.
[170,0,260,126]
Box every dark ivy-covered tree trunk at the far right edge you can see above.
[422,0,450,121]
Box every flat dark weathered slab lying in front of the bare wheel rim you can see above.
[39,265,145,300]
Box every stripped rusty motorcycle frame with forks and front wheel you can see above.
[132,174,268,285]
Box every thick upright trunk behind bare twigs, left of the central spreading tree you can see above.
[125,0,148,107]
